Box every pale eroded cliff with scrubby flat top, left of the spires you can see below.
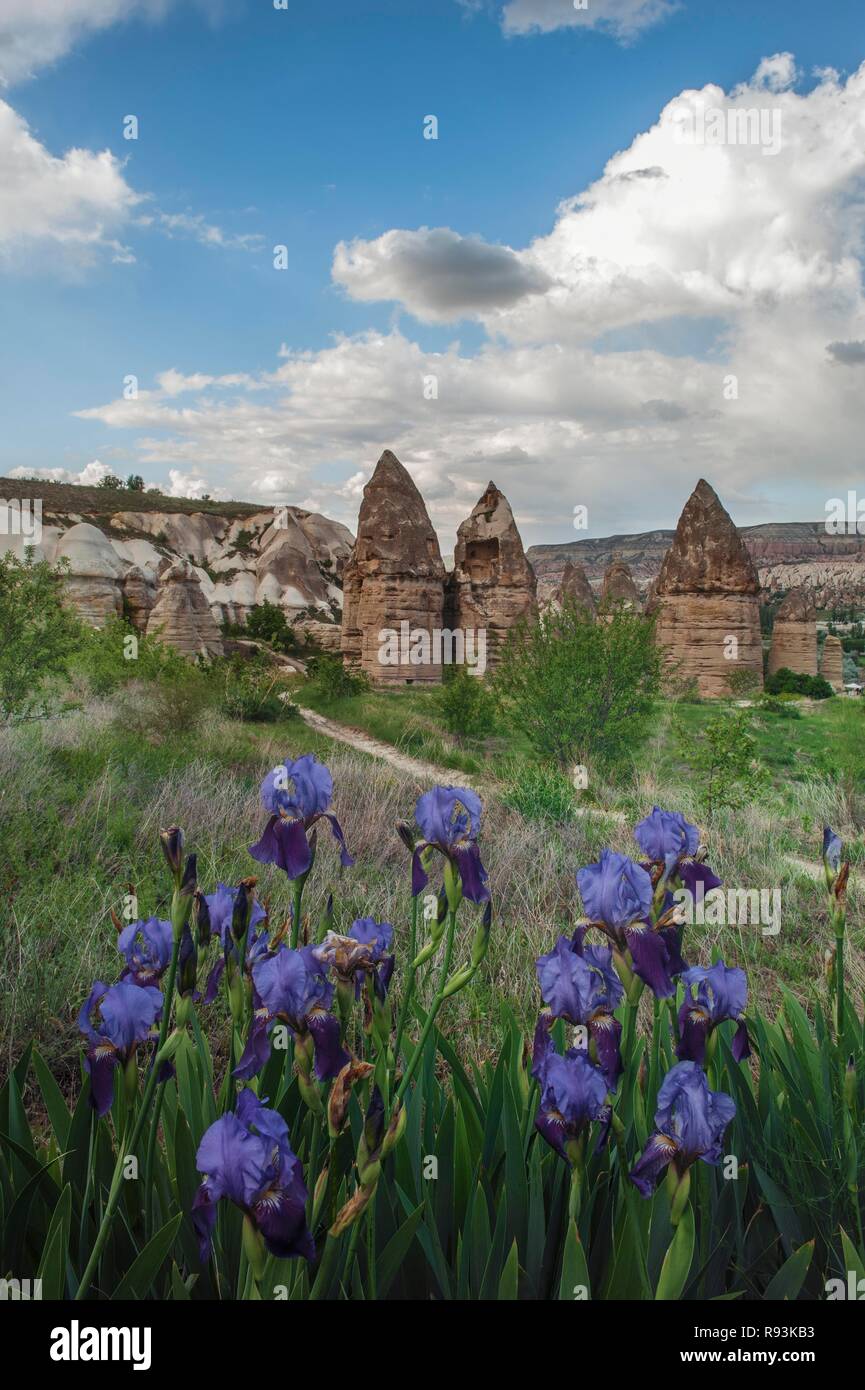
[0,478,353,645]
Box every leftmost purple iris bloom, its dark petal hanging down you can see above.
[78,980,163,1116]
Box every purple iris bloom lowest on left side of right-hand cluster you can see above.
[533,1020,611,1159]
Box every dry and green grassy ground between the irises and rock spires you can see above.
[0,689,865,1088]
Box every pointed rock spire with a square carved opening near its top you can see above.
[445,482,538,669]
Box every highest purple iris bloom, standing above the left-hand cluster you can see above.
[249,753,355,878]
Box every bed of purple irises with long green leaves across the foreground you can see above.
[0,795,865,1301]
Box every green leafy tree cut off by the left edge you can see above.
[0,549,81,720]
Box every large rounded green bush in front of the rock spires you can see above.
[492,602,661,767]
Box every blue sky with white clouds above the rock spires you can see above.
[0,0,865,541]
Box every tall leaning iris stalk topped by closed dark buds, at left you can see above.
[75,826,196,1302]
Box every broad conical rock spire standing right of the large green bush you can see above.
[652,478,762,698]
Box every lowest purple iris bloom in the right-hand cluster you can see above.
[630,1062,736,1197]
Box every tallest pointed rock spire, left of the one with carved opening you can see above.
[342,449,445,685]
